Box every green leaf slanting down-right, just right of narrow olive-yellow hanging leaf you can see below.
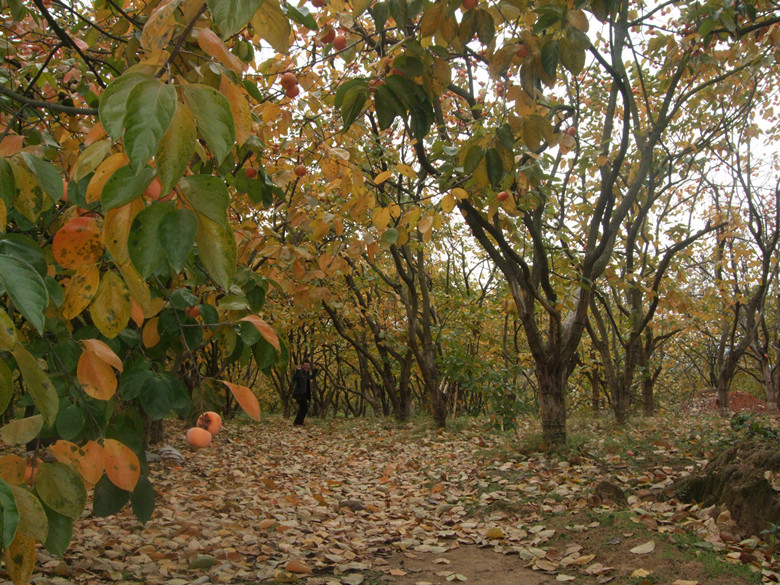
[184,83,235,164]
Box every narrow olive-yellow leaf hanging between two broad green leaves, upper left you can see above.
[154,102,198,194]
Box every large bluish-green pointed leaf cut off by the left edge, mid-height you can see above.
[0,254,49,334]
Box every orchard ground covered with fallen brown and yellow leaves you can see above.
[6,404,780,585]
